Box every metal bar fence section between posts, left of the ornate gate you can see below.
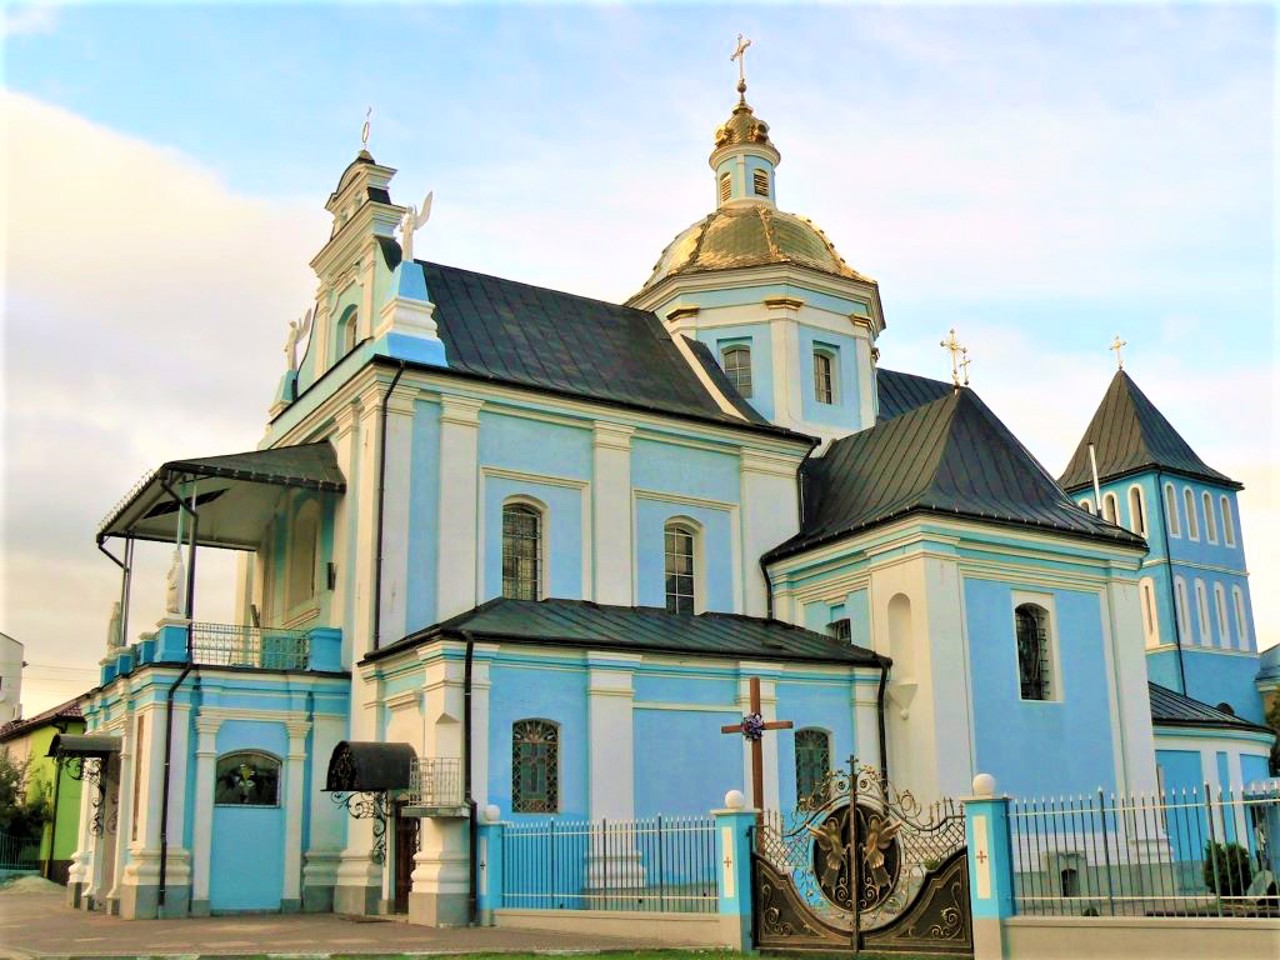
[502,817,719,913]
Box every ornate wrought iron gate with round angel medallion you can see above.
[751,759,973,956]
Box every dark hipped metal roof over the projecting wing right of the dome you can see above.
[765,388,1146,561]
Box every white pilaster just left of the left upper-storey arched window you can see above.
[436,396,483,621]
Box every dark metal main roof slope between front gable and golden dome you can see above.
[379,237,778,435]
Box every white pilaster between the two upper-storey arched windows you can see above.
[591,421,635,607]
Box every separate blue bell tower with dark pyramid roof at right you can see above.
[1059,367,1262,723]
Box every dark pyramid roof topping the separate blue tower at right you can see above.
[1059,370,1242,490]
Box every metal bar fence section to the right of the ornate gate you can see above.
[1010,781,1280,916]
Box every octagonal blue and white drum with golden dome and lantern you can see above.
[628,58,884,450]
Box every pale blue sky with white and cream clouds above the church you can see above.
[0,3,1280,716]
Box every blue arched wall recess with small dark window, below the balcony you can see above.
[209,750,284,913]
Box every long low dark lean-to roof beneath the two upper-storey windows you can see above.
[366,598,888,667]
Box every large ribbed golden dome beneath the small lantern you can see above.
[645,202,874,288]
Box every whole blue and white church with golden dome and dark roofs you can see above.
[64,71,1274,924]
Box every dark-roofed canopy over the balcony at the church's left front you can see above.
[97,440,347,550]
